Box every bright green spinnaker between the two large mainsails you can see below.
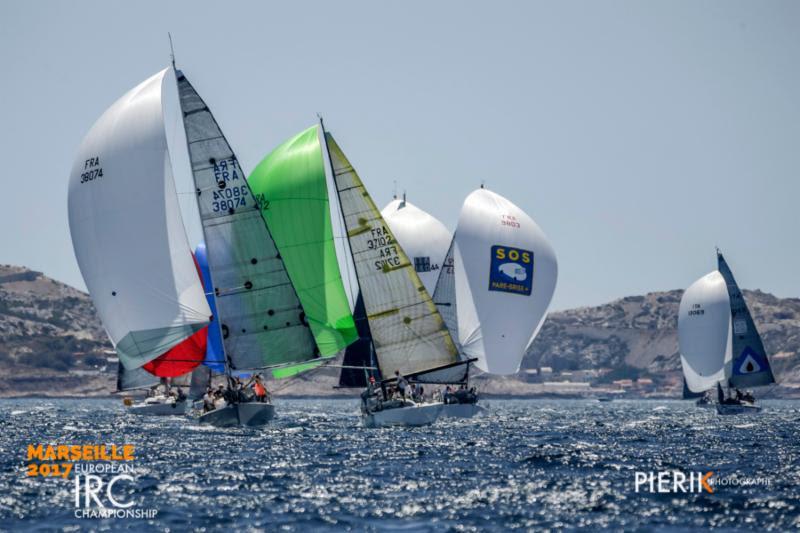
[248,126,358,357]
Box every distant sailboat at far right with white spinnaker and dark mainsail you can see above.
[678,250,775,414]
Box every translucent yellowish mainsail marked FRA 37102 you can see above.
[325,133,457,376]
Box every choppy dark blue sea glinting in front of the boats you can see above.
[0,399,800,531]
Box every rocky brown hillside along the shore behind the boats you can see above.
[0,265,800,397]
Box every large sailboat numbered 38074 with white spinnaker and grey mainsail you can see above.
[69,62,318,426]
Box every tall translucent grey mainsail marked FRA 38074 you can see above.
[177,71,318,370]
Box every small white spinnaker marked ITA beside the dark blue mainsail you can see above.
[678,270,732,392]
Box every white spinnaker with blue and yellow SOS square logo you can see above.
[454,189,558,375]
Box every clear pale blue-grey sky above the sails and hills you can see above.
[0,0,800,309]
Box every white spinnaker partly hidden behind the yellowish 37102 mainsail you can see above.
[381,199,453,295]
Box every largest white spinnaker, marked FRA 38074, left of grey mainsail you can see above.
[69,69,211,369]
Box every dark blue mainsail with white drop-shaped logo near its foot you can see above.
[717,252,775,387]
